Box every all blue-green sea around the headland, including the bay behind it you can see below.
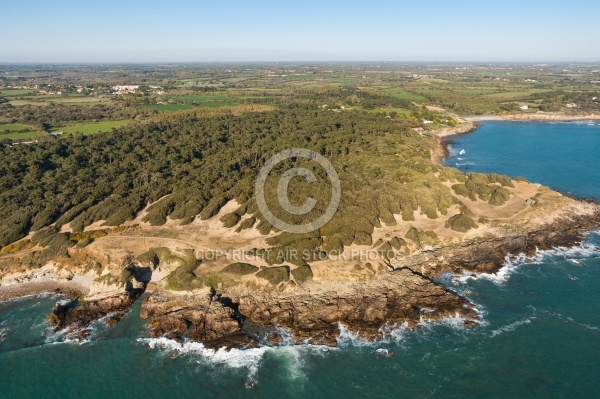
[0,122,600,398]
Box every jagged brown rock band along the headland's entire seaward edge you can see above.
[7,207,600,349]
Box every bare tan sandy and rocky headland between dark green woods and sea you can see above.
[0,122,600,348]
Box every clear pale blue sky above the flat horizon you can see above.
[0,0,600,62]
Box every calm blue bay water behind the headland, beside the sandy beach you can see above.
[444,120,600,199]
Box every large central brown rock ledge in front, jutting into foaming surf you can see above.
[141,269,477,348]
